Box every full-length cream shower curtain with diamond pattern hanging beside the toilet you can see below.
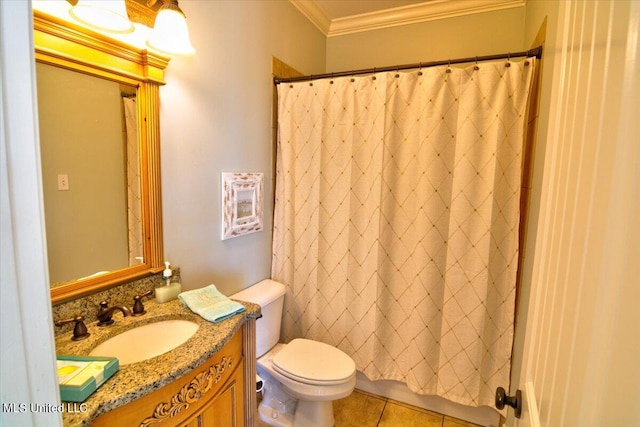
[272,58,535,406]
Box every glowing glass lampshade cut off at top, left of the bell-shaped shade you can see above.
[69,0,134,33]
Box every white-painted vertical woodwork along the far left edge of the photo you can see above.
[0,0,62,427]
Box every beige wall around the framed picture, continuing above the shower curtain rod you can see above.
[160,0,536,300]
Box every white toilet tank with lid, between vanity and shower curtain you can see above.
[230,279,286,357]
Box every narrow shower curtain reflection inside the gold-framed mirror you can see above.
[122,96,144,266]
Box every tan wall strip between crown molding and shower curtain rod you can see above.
[327,7,525,72]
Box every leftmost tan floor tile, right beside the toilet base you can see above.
[333,390,385,427]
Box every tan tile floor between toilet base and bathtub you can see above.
[257,390,480,427]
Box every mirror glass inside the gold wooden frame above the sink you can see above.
[36,63,144,286]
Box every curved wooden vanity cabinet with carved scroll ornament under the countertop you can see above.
[92,328,245,427]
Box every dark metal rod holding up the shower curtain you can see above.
[273,46,542,84]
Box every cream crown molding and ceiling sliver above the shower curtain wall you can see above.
[289,0,526,37]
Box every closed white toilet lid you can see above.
[271,338,356,385]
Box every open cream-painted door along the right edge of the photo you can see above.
[507,0,640,427]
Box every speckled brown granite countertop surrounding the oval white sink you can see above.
[56,300,260,427]
